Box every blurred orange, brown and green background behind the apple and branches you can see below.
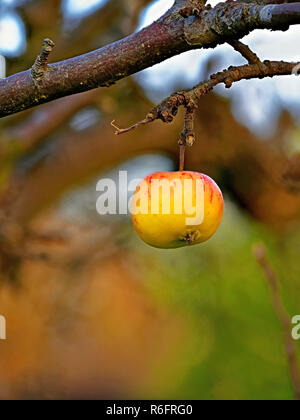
[0,0,300,399]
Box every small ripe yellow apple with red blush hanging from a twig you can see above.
[131,171,224,248]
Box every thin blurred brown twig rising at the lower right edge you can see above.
[253,244,300,400]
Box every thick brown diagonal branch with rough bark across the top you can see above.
[0,0,300,117]
